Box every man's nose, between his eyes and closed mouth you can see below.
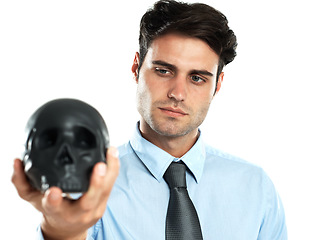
[168,76,187,102]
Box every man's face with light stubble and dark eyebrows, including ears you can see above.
[132,34,223,140]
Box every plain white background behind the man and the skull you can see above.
[0,0,316,239]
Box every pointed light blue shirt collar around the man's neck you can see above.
[130,124,205,183]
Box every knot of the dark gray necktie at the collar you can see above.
[163,162,187,189]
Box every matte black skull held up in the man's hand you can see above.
[23,99,109,193]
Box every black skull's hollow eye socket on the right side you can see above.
[74,127,97,149]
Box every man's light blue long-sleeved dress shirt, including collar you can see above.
[37,123,287,240]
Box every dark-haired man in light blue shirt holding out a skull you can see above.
[12,1,287,240]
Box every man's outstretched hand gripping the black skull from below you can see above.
[12,147,120,240]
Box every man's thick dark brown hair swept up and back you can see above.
[139,0,237,84]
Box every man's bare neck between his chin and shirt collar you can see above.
[139,121,199,158]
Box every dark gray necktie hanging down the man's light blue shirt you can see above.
[164,162,203,240]
